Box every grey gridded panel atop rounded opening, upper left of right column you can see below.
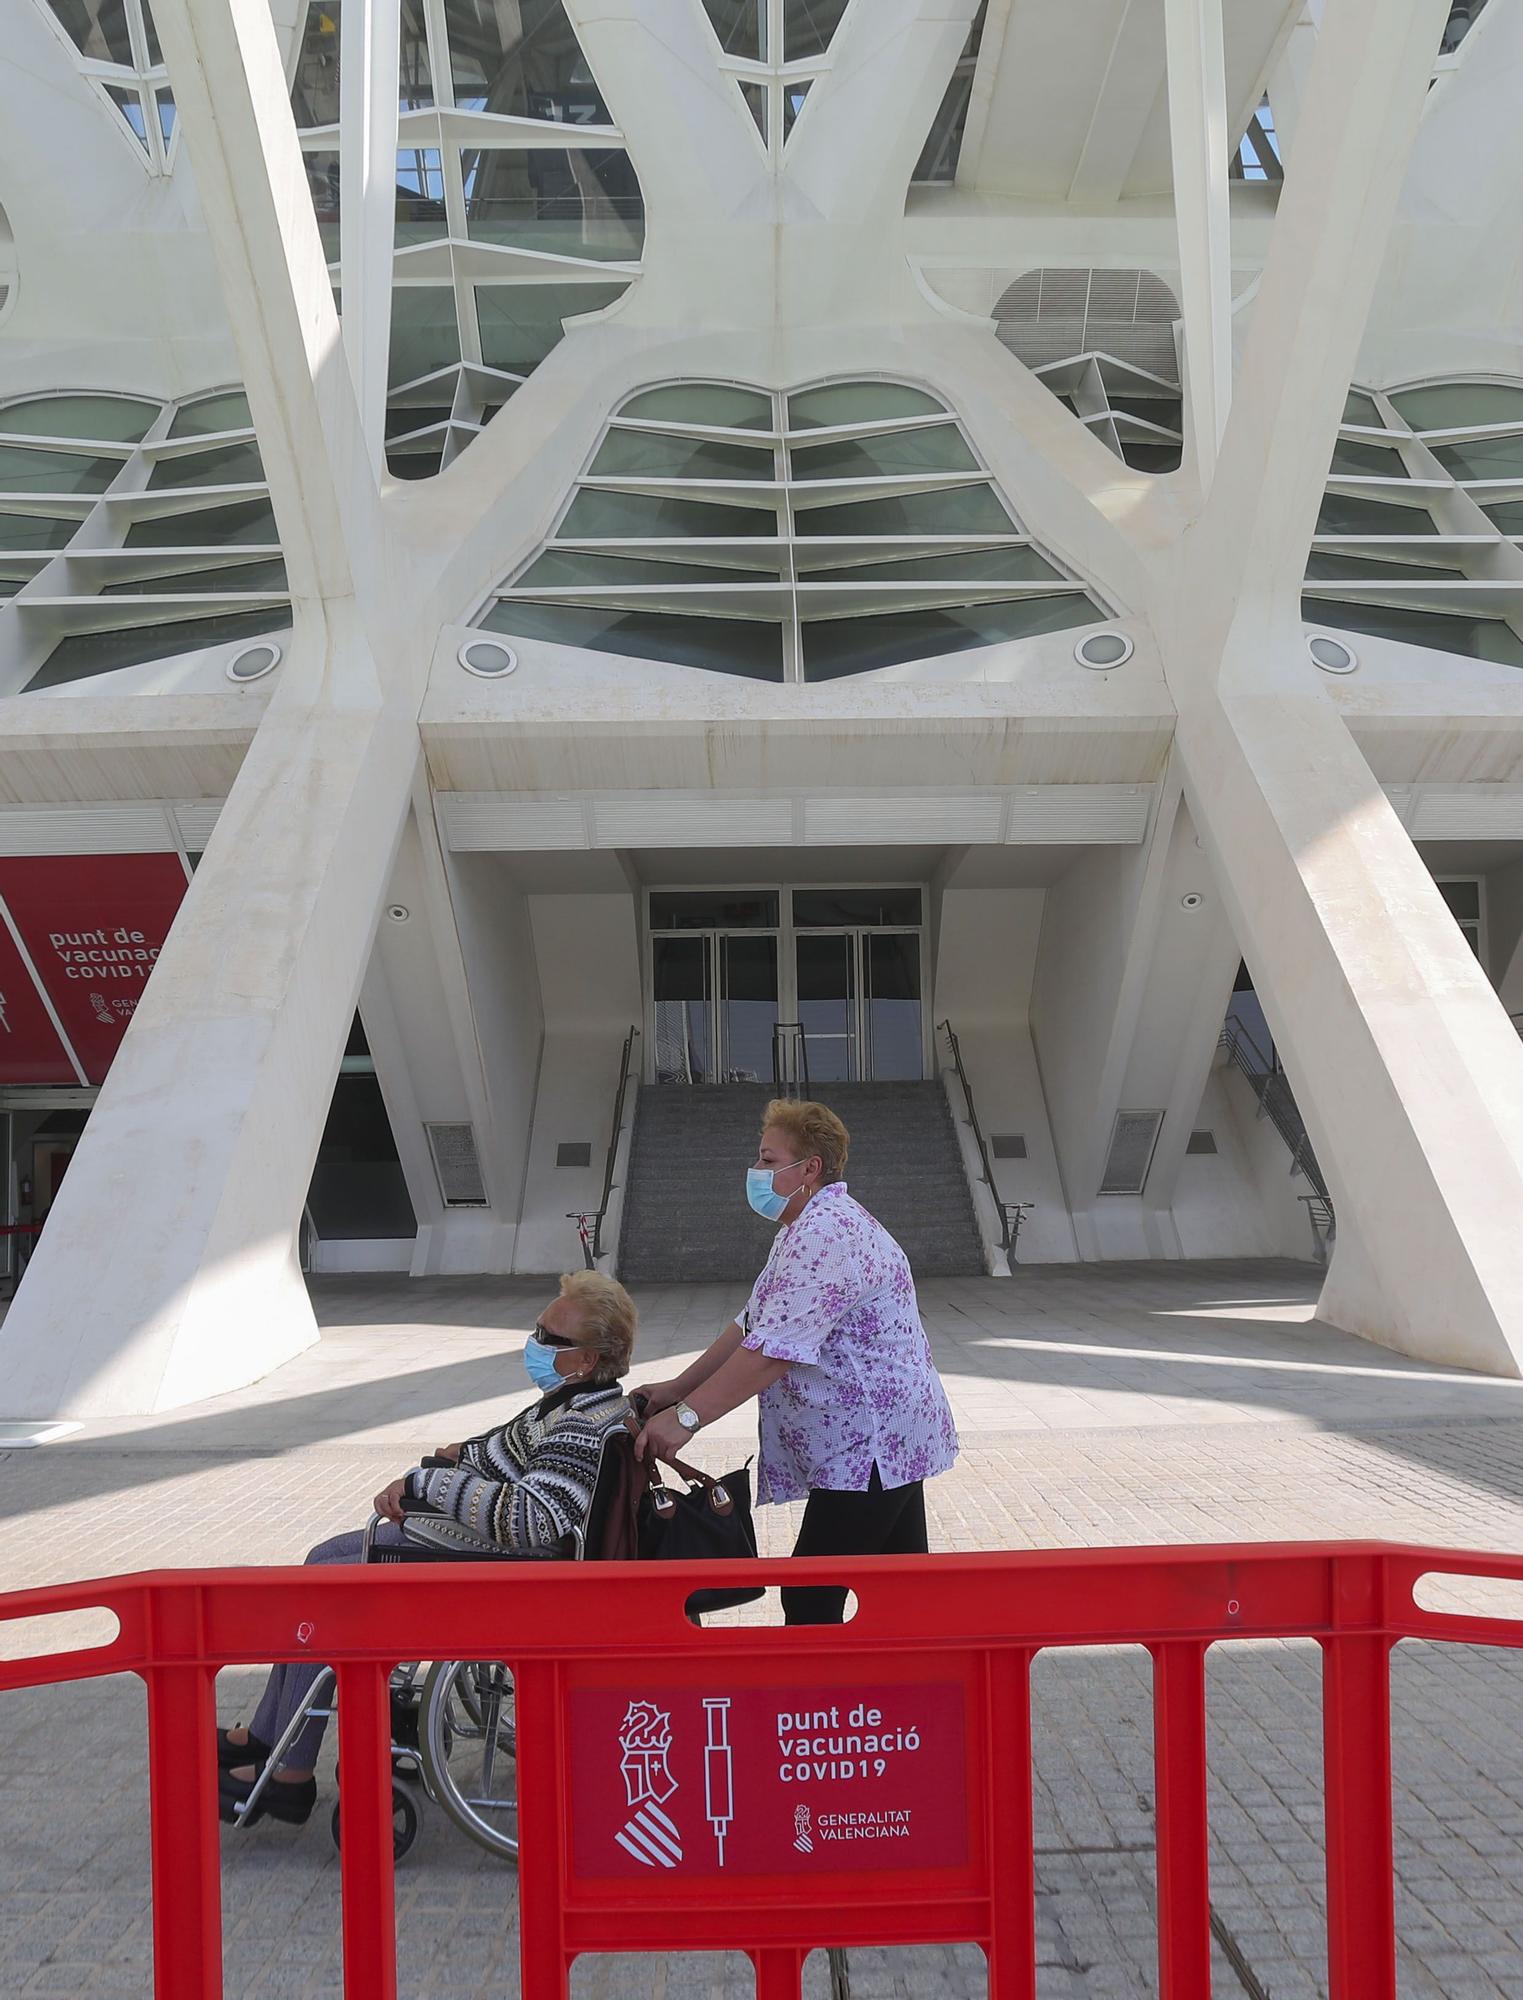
[993,268,1179,380]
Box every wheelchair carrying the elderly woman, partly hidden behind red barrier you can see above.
[223,1432,634,1862]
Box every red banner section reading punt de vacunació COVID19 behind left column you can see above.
[0,854,186,1084]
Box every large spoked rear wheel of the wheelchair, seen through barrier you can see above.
[418,1660,518,1860]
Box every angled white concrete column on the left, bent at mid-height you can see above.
[0,0,432,1416]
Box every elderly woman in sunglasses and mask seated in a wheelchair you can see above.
[218,1270,638,1854]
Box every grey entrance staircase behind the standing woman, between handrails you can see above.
[618,1080,985,1280]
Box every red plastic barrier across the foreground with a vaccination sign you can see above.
[0,1542,1523,2000]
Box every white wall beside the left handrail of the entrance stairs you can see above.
[514,890,644,1272]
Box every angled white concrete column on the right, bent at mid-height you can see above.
[1155,0,1523,1374]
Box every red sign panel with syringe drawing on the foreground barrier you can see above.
[572,1682,967,1878]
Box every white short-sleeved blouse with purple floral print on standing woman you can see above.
[742,1180,957,1504]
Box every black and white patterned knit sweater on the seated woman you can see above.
[406,1382,630,1554]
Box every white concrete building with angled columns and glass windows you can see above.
[0,0,1523,1418]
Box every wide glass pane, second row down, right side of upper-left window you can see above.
[460,148,646,262]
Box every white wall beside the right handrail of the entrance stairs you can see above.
[935,888,1075,1264]
